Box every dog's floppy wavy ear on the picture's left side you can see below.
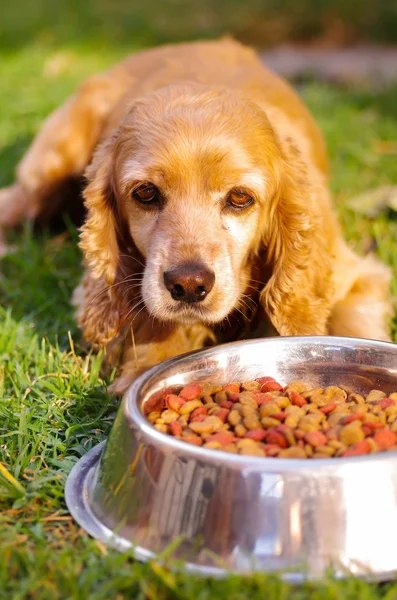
[73,133,135,346]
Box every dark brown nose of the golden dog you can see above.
[164,263,215,302]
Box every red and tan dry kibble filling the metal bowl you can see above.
[143,377,397,458]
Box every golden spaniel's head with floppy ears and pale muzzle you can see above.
[81,84,332,342]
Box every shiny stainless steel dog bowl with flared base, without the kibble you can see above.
[66,337,397,581]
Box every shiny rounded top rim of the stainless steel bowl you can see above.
[122,336,397,473]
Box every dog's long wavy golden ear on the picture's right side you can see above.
[260,138,334,336]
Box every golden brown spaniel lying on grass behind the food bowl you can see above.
[0,40,391,391]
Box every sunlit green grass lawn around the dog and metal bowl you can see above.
[0,1,397,600]
